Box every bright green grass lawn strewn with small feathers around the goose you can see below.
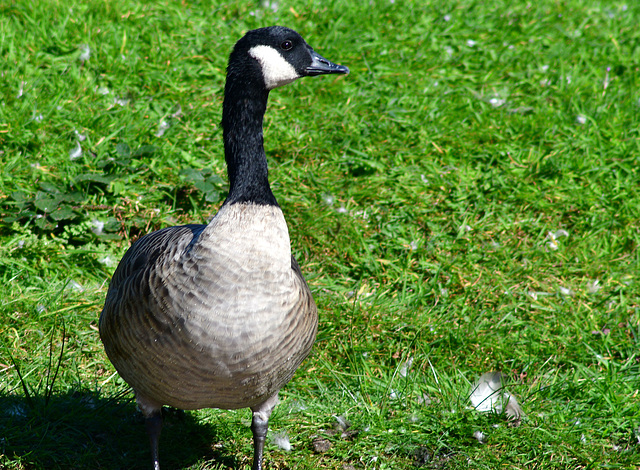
[0,0,640,470]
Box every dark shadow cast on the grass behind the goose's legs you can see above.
[0,391,239,470]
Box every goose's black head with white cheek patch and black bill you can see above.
[227,26,349,91]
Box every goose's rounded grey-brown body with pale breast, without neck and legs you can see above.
[100,204,317,409]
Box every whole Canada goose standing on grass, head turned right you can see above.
[100,26,349,470]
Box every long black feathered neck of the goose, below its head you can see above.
[222,70,278,206]
